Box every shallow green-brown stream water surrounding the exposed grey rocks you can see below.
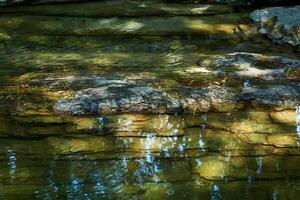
[0,1,300,200]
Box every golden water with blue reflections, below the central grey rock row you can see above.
[0,111,300,199]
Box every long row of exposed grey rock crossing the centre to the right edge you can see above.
[50,73,300,115]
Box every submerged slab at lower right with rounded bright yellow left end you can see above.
[192,156,299,181]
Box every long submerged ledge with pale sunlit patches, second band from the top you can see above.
[0,13,256,40]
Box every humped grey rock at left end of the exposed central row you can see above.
[54,81,181,115]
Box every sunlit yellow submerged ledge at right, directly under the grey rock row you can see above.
[186,110,296,134]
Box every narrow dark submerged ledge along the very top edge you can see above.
[0,0,233,17]
